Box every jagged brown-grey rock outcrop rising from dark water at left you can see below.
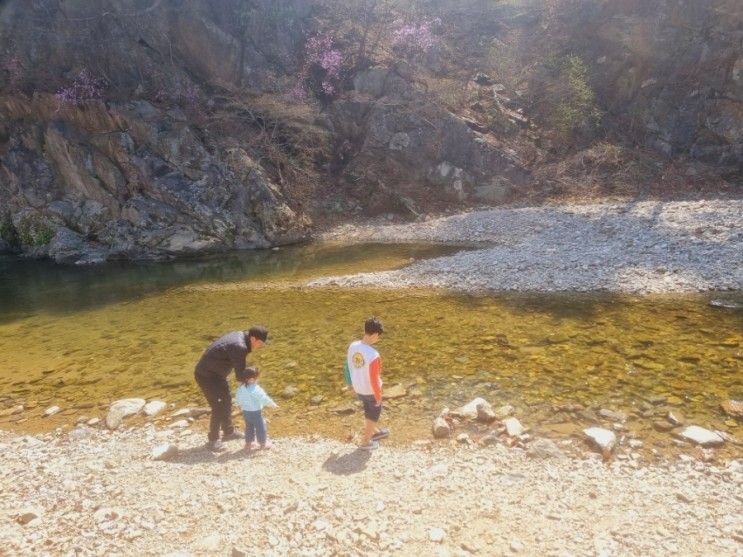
[0,94,309,263]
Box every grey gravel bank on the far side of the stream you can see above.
[310,200,743,293]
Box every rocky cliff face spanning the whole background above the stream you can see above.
[0,0,743,263]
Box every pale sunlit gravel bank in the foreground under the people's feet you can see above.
[0,426,743,556]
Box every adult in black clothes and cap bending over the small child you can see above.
[194,325,268,451]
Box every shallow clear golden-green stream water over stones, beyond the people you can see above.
[0,246,743,458]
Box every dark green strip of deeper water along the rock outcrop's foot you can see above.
[0,244,456,322]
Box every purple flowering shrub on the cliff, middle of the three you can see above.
[291,35,343,100]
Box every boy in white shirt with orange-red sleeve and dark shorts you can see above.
[346,317,390,451]
